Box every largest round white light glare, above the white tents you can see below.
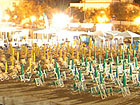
[52,13,70,28]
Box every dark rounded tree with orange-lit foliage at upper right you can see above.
[110,3,140,21]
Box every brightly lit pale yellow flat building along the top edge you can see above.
[70,0,133,10]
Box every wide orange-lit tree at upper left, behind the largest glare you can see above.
[6,0,70,23]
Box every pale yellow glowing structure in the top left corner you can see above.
[0,0,22,20]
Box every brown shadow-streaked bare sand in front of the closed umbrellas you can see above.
[0,80,140,105]
